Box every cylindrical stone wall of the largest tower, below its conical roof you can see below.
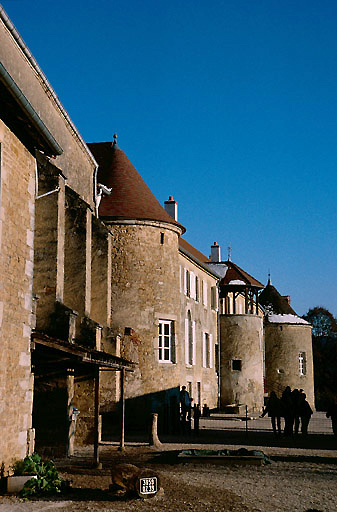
[106,221,183,398]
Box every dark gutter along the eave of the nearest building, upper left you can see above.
[0,62,63,156]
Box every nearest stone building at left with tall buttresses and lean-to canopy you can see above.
[0,7,132,469]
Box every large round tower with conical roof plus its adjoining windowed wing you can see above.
[88,138,217,431]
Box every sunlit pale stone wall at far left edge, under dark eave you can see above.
[0,121,35,468]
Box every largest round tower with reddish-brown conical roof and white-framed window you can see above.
[89,140,185,420]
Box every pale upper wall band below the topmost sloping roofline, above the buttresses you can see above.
[0,20,95,206]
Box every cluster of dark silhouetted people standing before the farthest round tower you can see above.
[261,386,312,436]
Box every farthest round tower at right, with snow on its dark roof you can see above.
[260,280,315,408]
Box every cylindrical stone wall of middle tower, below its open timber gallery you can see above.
[220,314,264,412]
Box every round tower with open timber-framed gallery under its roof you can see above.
[215,261,264,412]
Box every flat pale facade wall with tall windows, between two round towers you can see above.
[179,253,218,408]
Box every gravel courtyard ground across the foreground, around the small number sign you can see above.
[0,414,337,512]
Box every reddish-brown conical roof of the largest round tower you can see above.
[88,142,185,232]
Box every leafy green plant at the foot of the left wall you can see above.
[12,453,67,498]
